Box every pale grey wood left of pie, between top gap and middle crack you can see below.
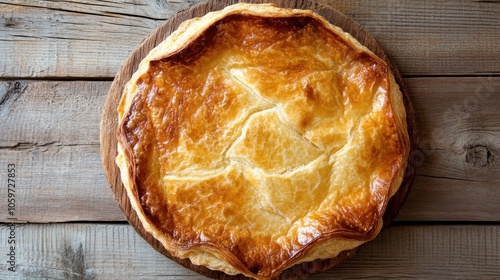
[0,80,105,149]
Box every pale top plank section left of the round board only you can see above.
[0,0,205,78]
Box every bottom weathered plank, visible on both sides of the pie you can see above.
[0,223,500,279]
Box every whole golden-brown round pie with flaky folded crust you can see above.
[116,4,409,279]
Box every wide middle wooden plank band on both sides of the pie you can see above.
[0,77,500,222]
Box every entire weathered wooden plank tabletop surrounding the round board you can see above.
[0,0,500,279]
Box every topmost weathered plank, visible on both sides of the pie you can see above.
[0,0,500,78]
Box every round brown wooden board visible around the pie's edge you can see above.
[100,0,418,279]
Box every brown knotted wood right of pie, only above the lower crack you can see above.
[409,76,500,180]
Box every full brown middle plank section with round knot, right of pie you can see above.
[398,76,500,221]
